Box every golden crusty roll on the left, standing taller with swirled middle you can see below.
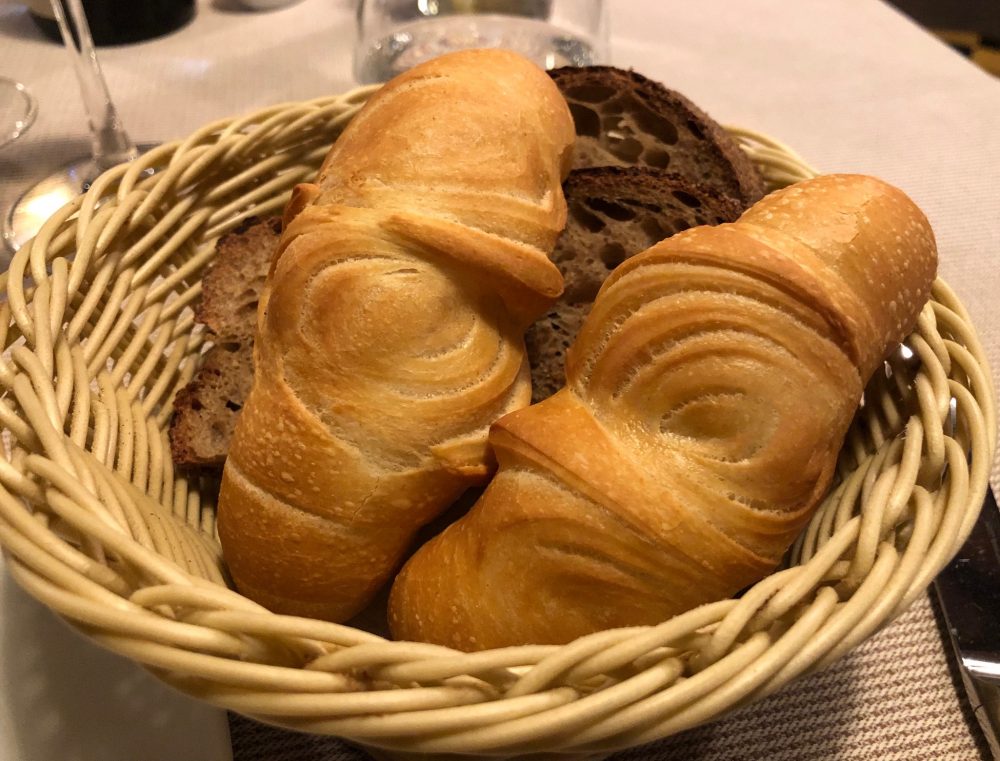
[218,50,574,621]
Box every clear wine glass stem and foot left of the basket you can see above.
[2,0,148,251]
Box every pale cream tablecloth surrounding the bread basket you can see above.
[0,0,1000,761]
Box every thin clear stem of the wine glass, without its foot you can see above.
[52,0,139,171]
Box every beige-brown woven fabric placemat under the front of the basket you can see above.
[229,595,990,761]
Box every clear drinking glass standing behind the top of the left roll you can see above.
[354,0,608,84]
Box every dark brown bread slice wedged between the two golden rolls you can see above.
[525,167,743,402]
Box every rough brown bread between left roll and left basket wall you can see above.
[170,212,281,468]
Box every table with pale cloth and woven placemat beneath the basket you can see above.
[0,0,1000,761]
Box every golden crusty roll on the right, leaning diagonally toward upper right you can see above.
[390,175,937,650]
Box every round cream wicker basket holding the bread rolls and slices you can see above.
[0,89,996,758]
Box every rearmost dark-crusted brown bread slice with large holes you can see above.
[550,66,764,206]
